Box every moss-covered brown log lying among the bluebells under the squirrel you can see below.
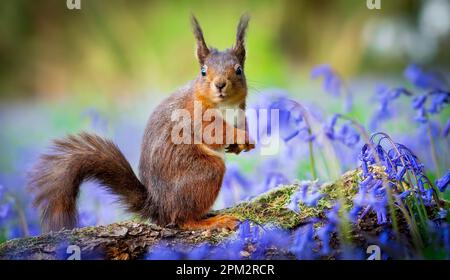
[0,167,414,260]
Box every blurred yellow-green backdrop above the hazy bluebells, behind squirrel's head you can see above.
[0,0,450,100]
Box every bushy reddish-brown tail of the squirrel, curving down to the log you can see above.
[29,133,148,232]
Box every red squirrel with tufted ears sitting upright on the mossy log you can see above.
[29,15,254,232]
